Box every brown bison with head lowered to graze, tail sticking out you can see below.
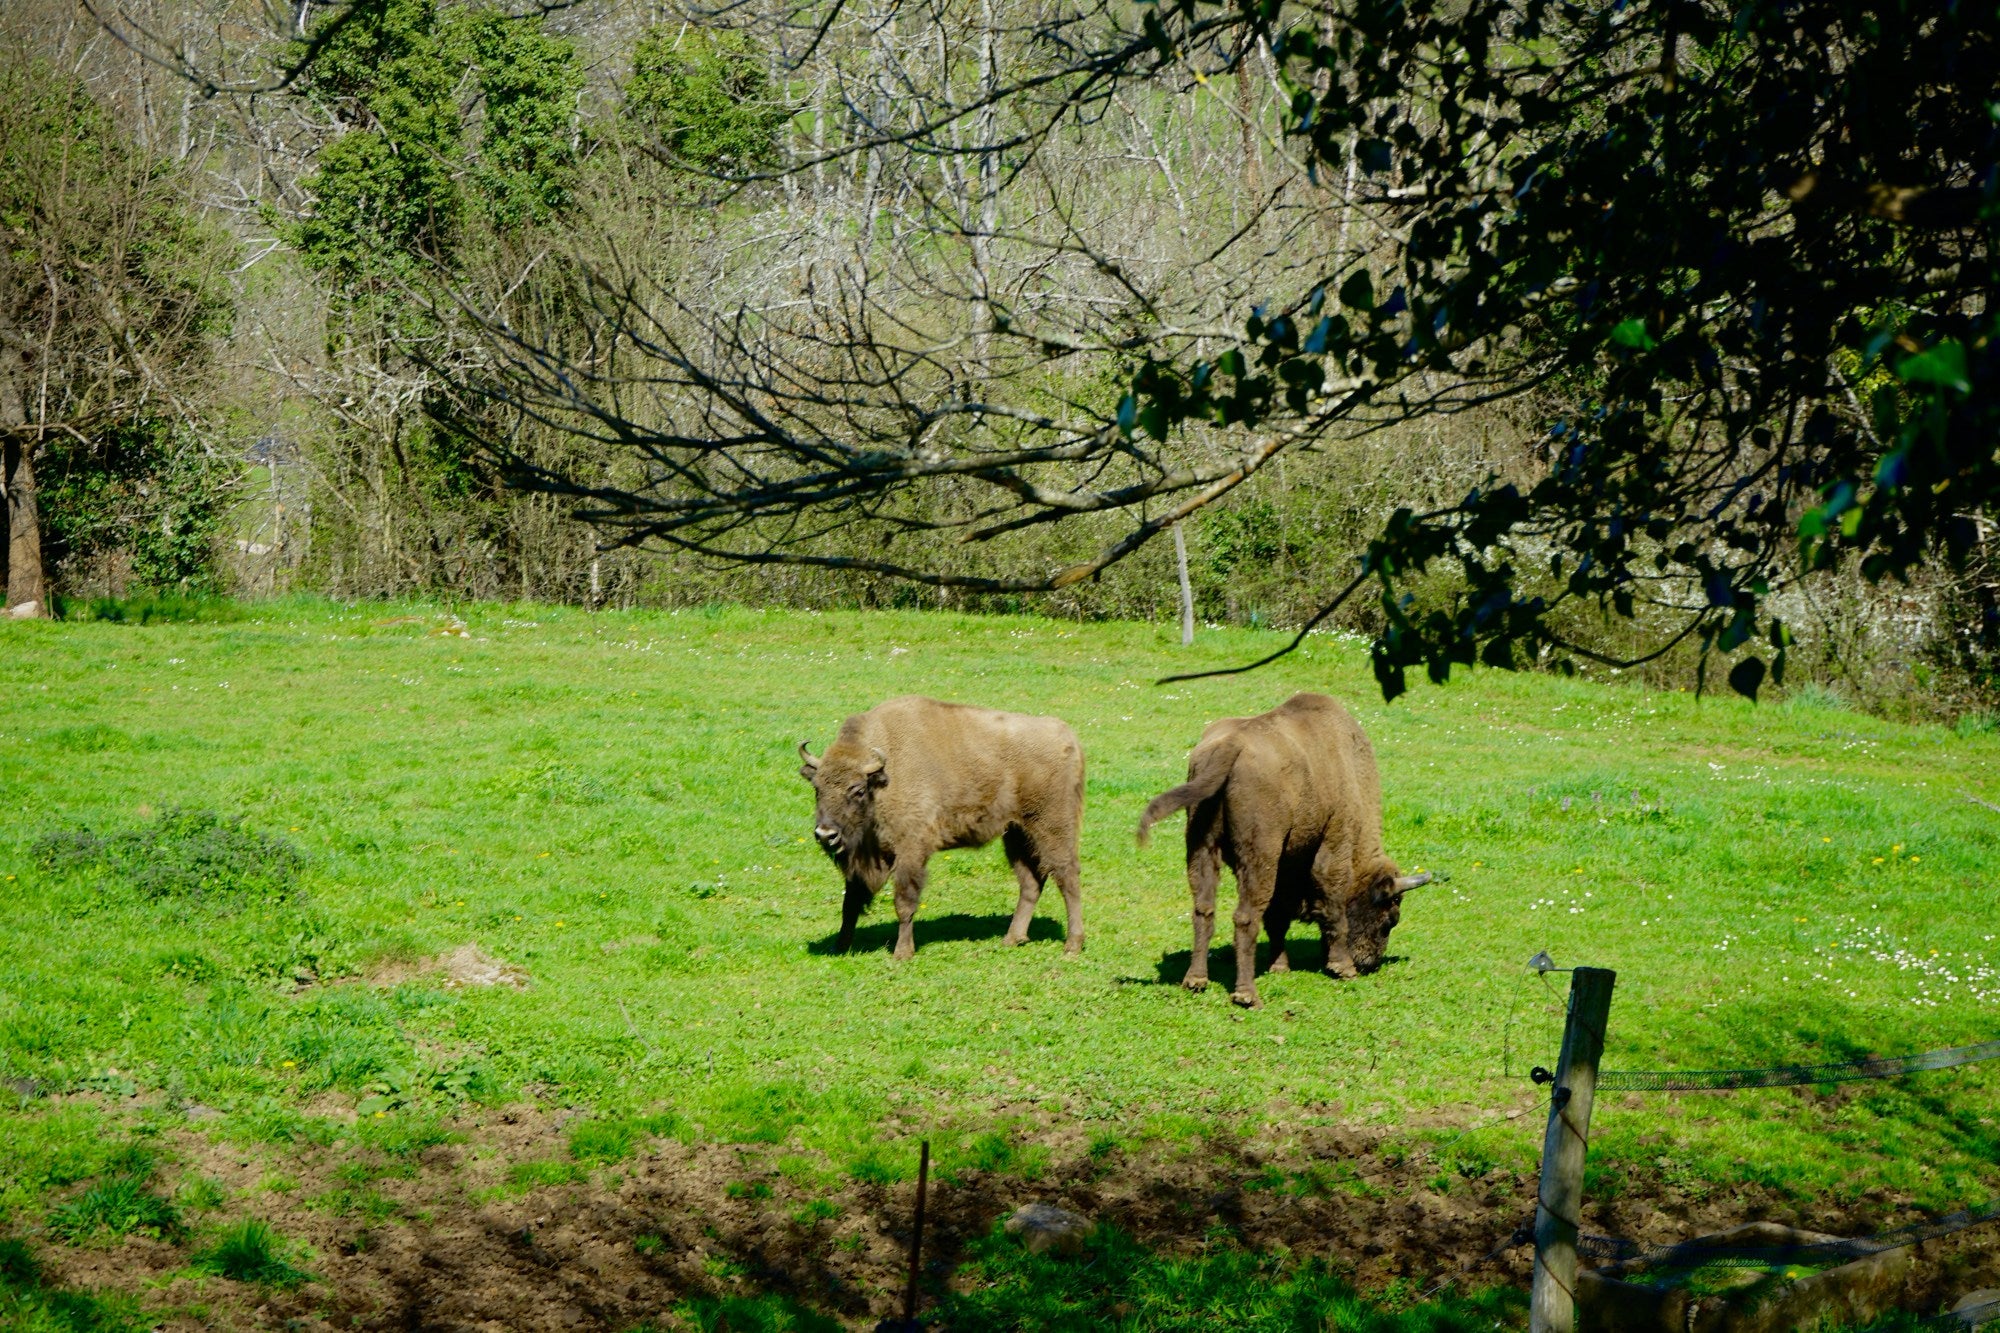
[1138,695,1430,1007]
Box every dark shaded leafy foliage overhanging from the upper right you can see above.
[1118,0,2000,697]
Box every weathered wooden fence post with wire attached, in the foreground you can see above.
[1528,967,1618,1333]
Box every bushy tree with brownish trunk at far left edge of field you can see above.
[0,50,234,588]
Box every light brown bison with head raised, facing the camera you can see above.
[798,695,1084,959]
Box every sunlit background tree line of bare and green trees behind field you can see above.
[0,0,1996,707]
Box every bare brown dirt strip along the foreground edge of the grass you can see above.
[35,1107,2000,1333]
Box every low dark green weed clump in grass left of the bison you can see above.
[34,807,306,903]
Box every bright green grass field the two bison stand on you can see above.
[0,602,2000,1327]
